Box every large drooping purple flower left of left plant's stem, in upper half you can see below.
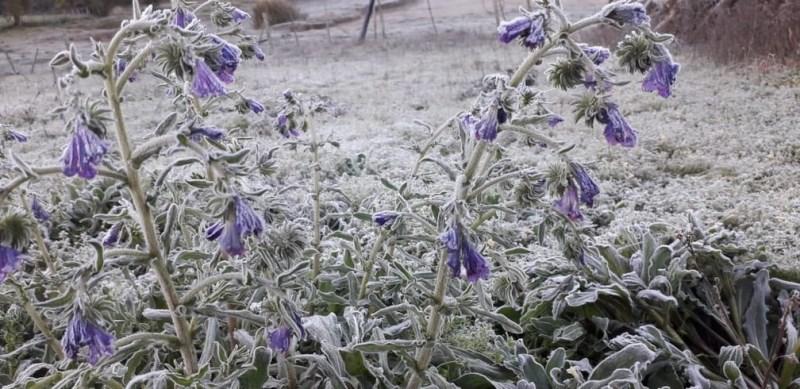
[61,120,108,180]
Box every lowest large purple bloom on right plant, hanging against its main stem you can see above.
[439,223,490,283]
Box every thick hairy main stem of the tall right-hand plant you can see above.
[406,32,569,382]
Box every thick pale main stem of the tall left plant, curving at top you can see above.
[105,36,197,374]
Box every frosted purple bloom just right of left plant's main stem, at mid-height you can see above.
[206,195,264,256]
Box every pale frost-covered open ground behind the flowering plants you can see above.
[0,0,800,264]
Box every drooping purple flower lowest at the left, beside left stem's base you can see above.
[61,310,114,365]
